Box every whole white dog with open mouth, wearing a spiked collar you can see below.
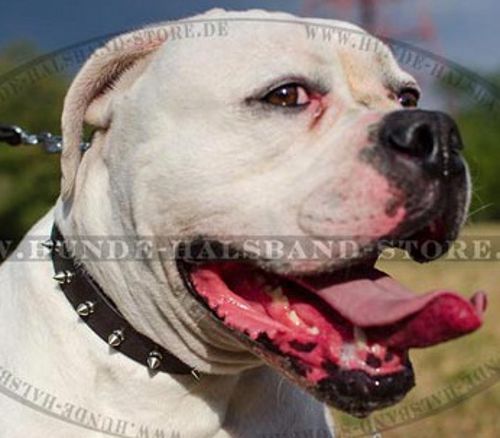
[0,10,484,438]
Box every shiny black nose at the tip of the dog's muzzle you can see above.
[379,110,464,177]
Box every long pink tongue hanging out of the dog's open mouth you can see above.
[299,269,486,349]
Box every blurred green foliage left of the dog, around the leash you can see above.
[0,42,68,248]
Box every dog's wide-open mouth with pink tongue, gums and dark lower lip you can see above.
[178,233,486,416]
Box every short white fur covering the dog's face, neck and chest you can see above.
[0,10,426,438]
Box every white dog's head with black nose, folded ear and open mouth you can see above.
[57,11,482,415]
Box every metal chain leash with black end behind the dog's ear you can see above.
[0,125,90,154]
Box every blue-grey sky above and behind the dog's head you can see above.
[0,0,500,73]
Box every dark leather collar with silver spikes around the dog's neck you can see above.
[44,225,198,378]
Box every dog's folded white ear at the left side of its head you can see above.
[61,28,164,200]
